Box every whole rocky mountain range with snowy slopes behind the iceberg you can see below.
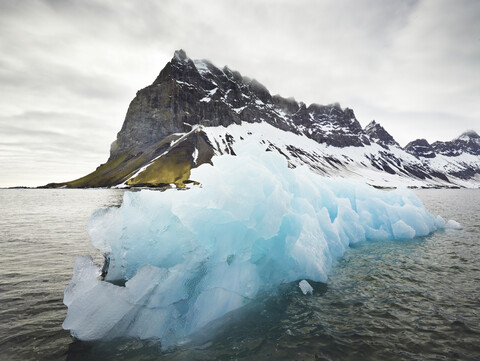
[46,50,480,187]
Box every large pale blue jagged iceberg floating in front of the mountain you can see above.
[63,144,453,346]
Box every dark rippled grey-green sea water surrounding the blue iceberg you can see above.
[0,190,480,360]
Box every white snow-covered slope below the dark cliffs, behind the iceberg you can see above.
[176,123,480,187]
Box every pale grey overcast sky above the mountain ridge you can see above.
[0,0,480,187]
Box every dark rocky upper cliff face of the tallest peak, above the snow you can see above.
[109,50,370,160]
